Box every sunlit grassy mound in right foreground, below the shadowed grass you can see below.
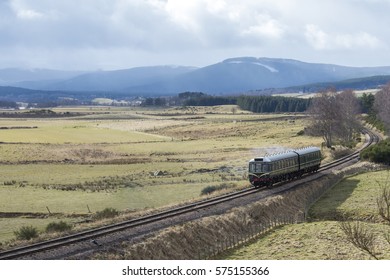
[225,221,390,260]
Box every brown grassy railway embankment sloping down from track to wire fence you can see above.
[86,162,383,259]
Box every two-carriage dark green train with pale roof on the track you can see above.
[248,147,322,187]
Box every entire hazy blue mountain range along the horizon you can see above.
[0,57,390,95]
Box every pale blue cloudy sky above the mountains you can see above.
[0,0,390,70]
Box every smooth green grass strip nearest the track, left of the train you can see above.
[0,180,207,214]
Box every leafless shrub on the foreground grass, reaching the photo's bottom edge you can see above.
[340,222,378,260]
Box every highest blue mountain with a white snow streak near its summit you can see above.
[127,57,390,94]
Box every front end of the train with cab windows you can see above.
[248,157,271,187]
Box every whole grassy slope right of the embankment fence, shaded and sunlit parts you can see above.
[225,171,390,260]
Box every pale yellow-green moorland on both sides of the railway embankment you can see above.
[0,105,389,259]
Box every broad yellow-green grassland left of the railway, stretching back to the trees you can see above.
[0,106,322,242]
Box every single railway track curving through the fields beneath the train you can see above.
[0,130,380,260]
